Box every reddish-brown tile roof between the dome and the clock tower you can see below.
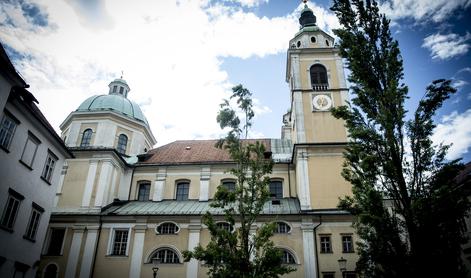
[138,139,271,165]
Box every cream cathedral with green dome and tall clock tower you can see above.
[37,6,358,278]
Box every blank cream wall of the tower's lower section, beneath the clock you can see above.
[308,147,352,209]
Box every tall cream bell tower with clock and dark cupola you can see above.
[284,1,351,209]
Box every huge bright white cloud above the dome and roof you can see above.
[0,0,338,145]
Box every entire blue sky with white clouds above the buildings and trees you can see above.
[0,0,471,161]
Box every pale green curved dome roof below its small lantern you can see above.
[76,95,148,125]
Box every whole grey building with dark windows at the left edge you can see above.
[0,45,72,277]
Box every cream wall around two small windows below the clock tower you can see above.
[316,222,358,277]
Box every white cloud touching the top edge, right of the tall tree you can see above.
[380,0,471,22]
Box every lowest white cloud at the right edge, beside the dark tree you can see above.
[432,109,471,159]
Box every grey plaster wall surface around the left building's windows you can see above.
[0,77,68,277]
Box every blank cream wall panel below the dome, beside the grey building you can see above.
[57,159,90,207]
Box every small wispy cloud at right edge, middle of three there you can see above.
[422,33,471,60]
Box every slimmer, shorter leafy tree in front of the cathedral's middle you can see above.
[184,85,294,278]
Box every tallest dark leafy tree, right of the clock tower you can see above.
[331,0,469,277]
